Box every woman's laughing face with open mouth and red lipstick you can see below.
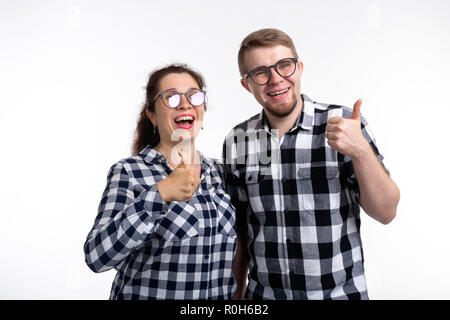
[147,73,205,145]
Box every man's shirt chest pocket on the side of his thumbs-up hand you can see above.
[298,166,341,214]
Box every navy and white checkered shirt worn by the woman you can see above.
[84,146,236,300]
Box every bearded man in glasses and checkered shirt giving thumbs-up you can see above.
[223,29,400,299]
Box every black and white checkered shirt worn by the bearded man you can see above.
[223,95,383,299]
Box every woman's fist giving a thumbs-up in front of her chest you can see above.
[156,158,201,203]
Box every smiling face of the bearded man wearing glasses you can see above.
[241,45,303,118]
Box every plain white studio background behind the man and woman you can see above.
[0,0,450,299]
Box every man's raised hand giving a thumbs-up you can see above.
[325,99,370,158]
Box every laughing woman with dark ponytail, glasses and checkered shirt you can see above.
[84,65,236,299]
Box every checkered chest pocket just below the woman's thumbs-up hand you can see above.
[155,201,199,241]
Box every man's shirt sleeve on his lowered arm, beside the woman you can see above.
[222,139,249,233]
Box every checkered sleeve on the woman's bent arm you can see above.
[84,163,168,272]
